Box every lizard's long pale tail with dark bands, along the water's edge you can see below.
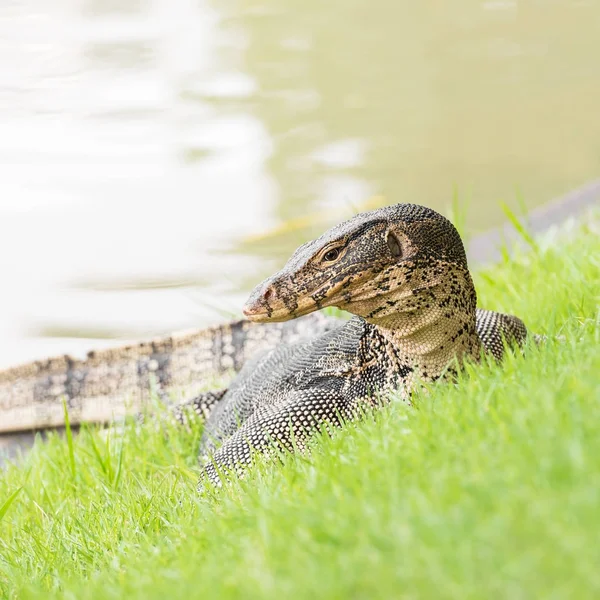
[0,315,335,432]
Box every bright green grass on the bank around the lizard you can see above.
[0,213,600,599]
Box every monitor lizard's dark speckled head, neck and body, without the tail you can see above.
[200,204,527,488]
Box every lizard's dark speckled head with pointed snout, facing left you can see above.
[244,204,476,325]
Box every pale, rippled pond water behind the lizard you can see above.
[0,0,600,366]
